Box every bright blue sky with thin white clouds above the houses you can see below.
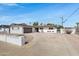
[0,3,79,27]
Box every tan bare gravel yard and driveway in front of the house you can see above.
[0,33,79,56]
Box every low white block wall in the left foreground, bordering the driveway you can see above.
[0,33,25,46]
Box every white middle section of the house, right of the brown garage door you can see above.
[33,25,57,33]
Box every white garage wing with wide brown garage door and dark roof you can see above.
[10,24,32,34]
